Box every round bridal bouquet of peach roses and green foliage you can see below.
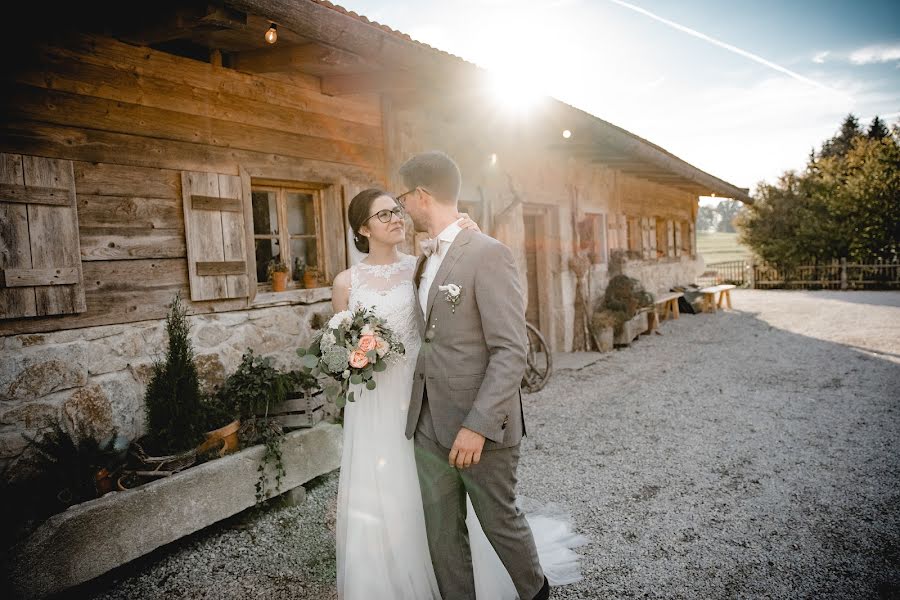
[297,307,406,408]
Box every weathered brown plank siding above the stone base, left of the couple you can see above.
[0,36,384,335]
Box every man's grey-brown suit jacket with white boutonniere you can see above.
[406,230,527,450]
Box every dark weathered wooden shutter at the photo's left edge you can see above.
[0,154,87,319]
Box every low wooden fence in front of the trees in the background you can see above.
[697,260,900,290]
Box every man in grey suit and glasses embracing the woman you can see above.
[397,152,550,600]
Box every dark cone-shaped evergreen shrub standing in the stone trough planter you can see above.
[144,295,206,453]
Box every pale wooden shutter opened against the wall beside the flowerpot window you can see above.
[181,171,250,301]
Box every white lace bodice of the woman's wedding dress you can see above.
[349,254,421,364]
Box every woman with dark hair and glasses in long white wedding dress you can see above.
[332,189,583,600]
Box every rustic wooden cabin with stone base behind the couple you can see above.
[0,0,747,478]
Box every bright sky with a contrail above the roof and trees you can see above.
[338,0,900,202]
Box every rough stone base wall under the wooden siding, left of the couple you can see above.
[0,301,331,480]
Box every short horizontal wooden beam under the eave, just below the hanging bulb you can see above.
[231,44,383,75]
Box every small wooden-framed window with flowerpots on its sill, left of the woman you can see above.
[252,185,323,288]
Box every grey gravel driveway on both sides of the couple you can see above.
[78,290,900,600]
